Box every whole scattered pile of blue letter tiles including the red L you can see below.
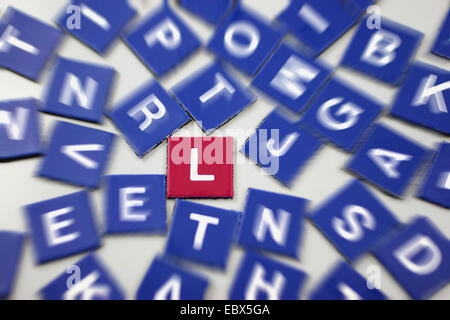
[0,0,450,299]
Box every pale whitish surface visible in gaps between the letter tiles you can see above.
[0,0,450,299]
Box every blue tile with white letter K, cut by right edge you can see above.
[390,62,450,134]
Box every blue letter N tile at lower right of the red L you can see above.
[238,188,307,258]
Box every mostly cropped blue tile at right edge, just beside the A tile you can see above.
[419,142,450,208]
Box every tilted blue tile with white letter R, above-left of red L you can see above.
[110,80,190,158]
